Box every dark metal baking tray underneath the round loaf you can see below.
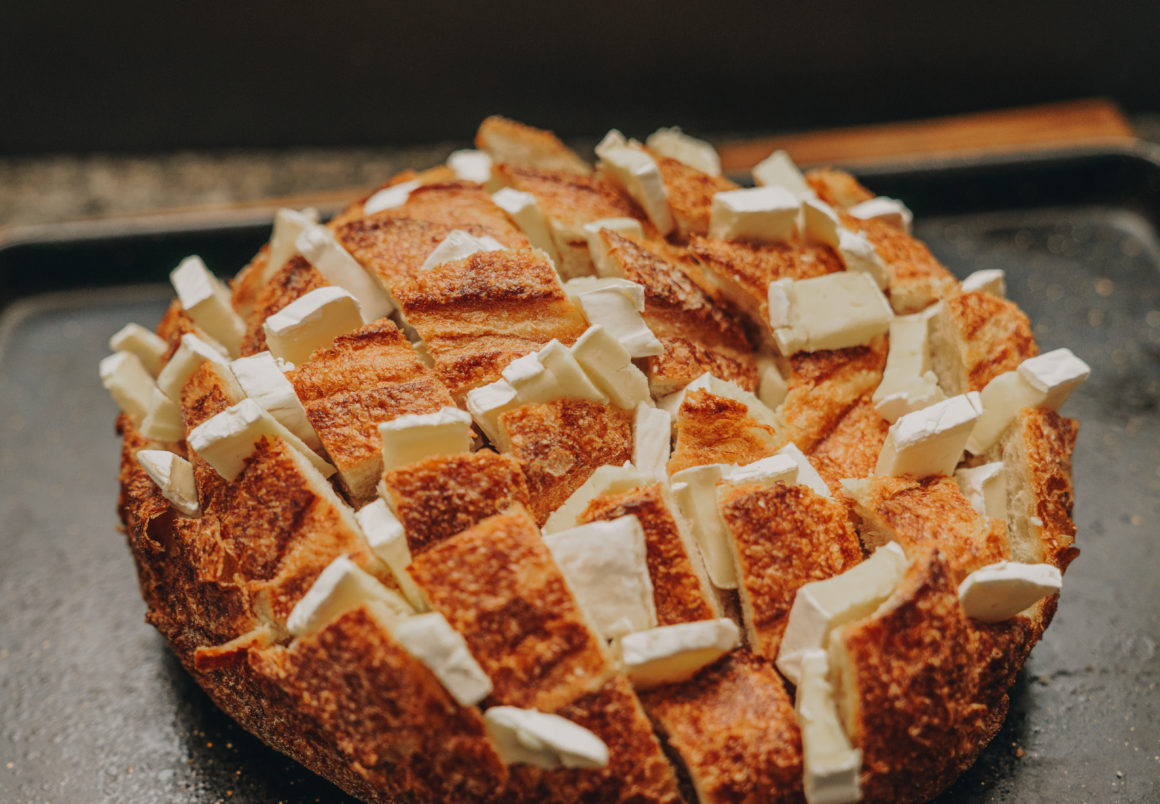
[0,146,1160,804]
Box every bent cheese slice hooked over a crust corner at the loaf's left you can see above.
[187,399,334,480]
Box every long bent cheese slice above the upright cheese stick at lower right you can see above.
[777,542,909,685]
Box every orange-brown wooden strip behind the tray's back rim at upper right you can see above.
[718,99,1133,172]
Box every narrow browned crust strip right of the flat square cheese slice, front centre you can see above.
[577,484,720,625]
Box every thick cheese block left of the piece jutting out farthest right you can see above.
[875,391,983,478]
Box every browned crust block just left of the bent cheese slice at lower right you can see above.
[718,483,862,659]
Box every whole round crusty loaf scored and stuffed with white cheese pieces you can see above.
[100,117,1088,804]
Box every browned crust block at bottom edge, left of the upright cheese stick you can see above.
[641,649,803,804]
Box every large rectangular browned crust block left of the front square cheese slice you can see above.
[408,507,611,711]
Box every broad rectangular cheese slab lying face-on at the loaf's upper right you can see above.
[769,271,894,355]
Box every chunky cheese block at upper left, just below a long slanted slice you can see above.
[262,285,363,364]
